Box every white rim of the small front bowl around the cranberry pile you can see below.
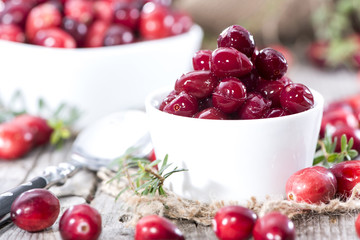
[145,86,324,124]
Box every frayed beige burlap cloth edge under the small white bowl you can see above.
[97,168,360,226]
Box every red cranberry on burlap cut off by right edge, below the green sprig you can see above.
[330,160,360,200]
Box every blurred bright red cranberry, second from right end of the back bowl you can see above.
[139,2,171,40]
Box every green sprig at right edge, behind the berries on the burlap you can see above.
[313,128,358,167]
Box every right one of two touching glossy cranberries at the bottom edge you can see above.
[253,212,295,240]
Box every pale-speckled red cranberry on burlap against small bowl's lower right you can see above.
[286,166,336,204]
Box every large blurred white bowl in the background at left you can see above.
[0,25,203,127]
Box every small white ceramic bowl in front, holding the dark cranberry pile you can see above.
[146,86,324,202]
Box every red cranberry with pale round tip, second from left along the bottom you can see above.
[59,204,101,240]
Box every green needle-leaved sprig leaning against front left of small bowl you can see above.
[109,148,187,199]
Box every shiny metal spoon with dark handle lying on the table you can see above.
[0,110,152,219]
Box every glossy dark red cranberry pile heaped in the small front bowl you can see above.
[159,25,314,119]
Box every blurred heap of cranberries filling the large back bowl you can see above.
[0,0,193,48]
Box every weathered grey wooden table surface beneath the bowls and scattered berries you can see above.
[0,64,358,240]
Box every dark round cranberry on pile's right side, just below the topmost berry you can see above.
[255,48,287,80]
